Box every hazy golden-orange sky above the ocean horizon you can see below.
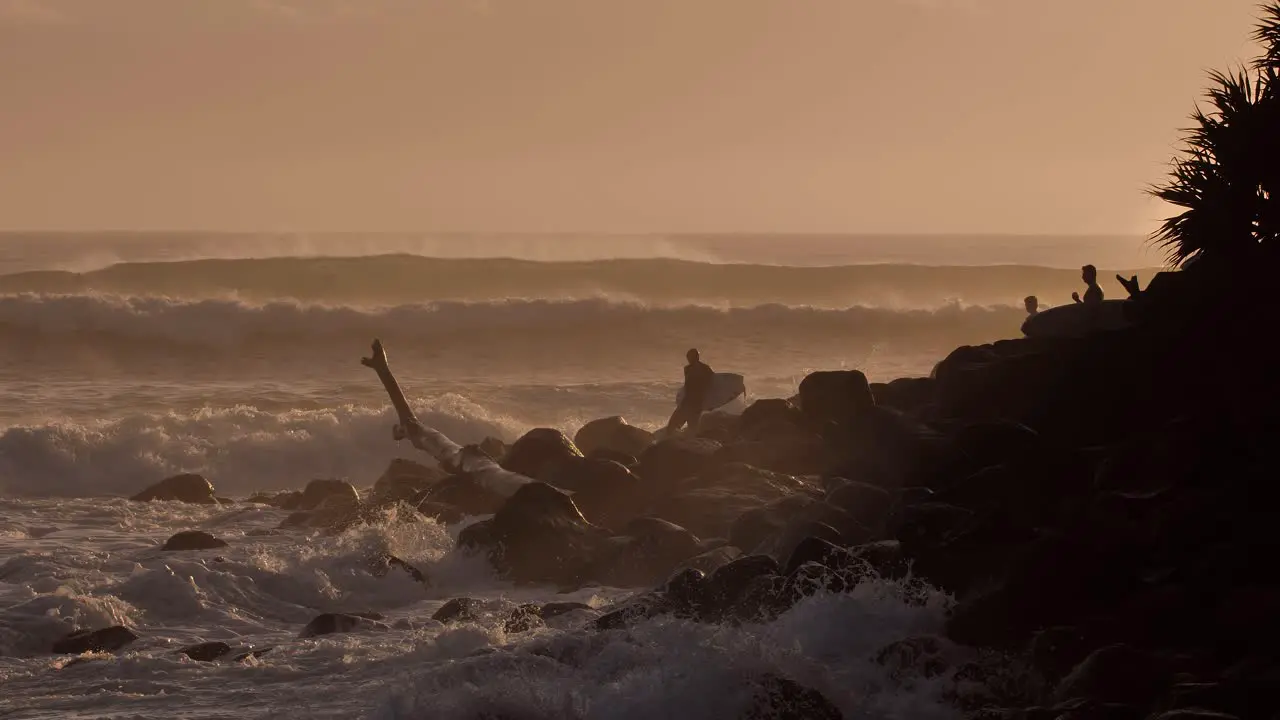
[0,0,1256,233]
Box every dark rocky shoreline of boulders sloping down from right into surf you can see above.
[97,258,1280,720]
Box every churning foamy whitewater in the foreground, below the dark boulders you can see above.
[0,500,963,720]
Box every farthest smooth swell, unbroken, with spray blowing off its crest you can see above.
[0,255,1151,307]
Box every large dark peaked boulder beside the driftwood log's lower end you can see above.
[468,482,605,587]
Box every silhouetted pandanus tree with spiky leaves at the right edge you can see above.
[1151,3,1280,265]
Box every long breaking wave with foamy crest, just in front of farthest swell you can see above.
[0,289,1023,348]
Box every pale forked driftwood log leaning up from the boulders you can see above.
[360,340,534,497]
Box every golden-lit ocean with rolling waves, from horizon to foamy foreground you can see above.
[0,233,1158,720]
